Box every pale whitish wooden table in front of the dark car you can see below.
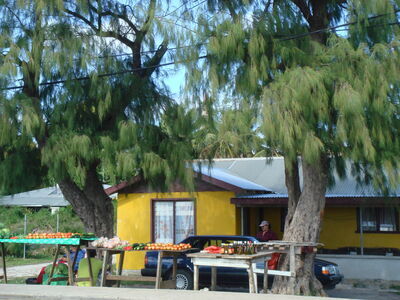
[187,251,273,293]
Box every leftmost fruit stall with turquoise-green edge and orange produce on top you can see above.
[0,232,97,285]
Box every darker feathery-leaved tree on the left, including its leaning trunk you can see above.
[0,0,198,237]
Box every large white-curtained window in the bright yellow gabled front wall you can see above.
[153,200,194,243]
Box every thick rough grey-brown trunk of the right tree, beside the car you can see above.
[272,158,328,295]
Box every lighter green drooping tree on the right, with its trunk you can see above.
[188,0,400,295]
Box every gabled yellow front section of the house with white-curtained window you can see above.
[113,170,268,270]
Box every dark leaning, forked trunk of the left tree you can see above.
[58,166,114,237]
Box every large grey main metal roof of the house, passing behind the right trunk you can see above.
[202,157,400,197]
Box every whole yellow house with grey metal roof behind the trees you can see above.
[113,158,400,270]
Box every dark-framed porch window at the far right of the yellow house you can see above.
[358,207,399,232]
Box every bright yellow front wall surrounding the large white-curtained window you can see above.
[117,192,236,270]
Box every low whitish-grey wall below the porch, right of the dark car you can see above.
[317,254,400,281]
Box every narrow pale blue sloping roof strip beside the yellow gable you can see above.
[193,165,272,192]
